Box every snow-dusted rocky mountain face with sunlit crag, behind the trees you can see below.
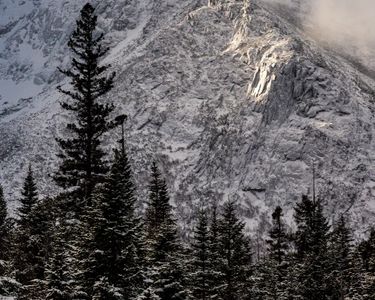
[0,0,375,234]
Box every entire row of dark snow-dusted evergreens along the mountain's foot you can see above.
[0,4,375,300]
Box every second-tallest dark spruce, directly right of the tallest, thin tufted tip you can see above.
[77,130,144,300]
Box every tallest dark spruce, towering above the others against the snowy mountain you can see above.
[55,3,115,199]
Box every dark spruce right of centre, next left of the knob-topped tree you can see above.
[219,202,251,300]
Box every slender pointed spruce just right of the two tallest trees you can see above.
[145,163,189,300]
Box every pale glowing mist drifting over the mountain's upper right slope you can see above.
[263,0,375,66]
